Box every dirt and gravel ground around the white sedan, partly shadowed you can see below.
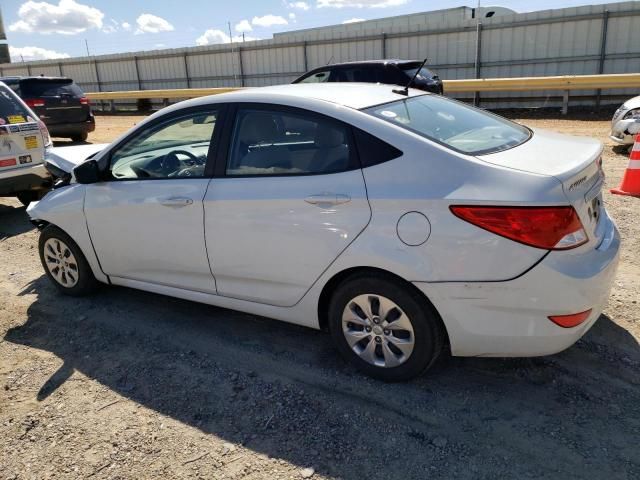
[0,113,640,480]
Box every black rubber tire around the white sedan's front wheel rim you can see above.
[38,225,99,297]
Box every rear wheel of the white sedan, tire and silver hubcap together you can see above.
[329,274,444,381]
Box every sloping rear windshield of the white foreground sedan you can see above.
[364,95,531,155]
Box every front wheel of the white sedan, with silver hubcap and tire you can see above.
[38,225,98,296]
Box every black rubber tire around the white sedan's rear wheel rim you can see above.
[329,273,445,382]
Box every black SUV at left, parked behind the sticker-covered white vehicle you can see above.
[0,77,96,142]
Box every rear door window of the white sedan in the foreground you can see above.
[226,108,357,176]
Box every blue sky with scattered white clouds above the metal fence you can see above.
[0,0,636,62]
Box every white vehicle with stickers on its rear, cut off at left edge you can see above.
[0,82,51,205]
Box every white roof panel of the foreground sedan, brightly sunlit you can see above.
[182,82,429,110]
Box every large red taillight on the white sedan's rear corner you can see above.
[450,205,587,250]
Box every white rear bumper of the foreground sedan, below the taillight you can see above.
[416,211,620,357]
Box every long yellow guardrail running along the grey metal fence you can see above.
[87,73,640,100]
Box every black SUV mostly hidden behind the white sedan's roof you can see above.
[293,60,444,95]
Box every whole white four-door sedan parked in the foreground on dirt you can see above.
[28,84,620,380]
